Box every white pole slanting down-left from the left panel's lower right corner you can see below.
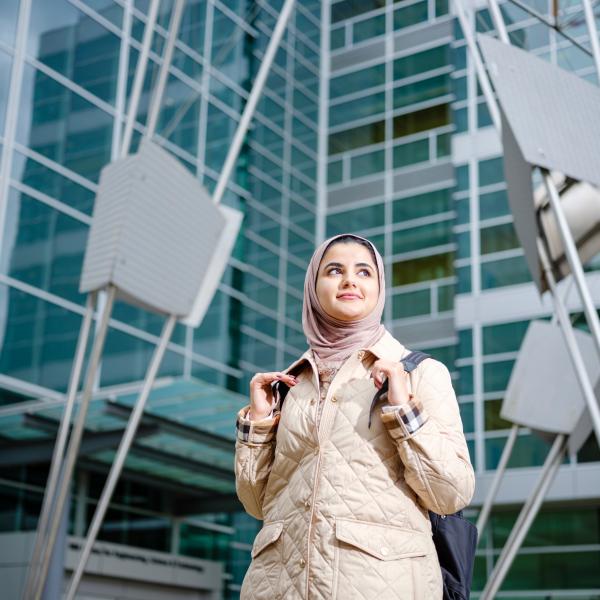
[66,315,177,600]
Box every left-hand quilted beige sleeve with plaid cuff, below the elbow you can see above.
[235,406,279,519]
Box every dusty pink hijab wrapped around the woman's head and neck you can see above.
[302,234,385,363]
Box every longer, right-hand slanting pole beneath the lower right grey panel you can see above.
[480,434,567,600]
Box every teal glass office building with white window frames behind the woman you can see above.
[0,0,600,600]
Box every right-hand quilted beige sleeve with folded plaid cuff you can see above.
[381,359,475,515]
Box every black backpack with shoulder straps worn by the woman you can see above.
[273,351,477,600]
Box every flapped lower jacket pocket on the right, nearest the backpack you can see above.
[333,518,433,600]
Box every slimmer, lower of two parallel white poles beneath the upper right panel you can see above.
[537,237,600,444]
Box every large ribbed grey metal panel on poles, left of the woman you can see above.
[80,140,241,326]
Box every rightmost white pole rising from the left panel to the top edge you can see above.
[213,0,295,204]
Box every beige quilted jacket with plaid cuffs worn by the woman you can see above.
[236,333,474,600]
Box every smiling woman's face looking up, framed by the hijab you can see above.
[317,243,379,321]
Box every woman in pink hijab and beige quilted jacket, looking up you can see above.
[236,235,474,600]
